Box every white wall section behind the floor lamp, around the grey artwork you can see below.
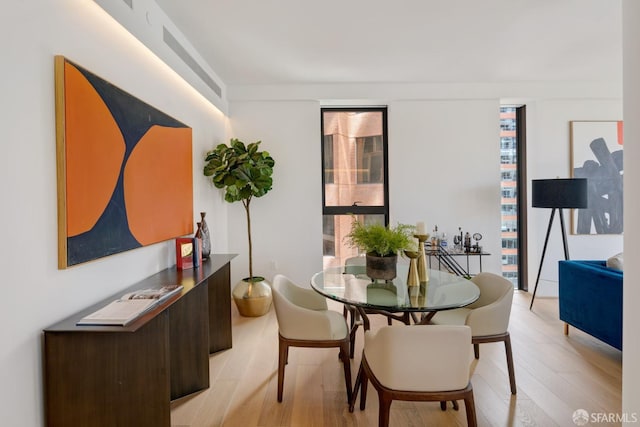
[526,98,626,297]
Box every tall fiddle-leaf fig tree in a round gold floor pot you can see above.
[204,138,275,317]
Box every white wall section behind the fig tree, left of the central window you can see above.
[228,101,322,284]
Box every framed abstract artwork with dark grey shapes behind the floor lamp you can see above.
[570,121,624,234]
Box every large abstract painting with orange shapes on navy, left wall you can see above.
[55,56,193,268]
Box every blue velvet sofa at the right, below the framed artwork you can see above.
[558,261,623,350]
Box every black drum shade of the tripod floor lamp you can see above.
[531,178,588,209]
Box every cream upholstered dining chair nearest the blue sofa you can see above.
[431,272,517,394]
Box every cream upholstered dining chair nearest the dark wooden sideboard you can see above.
[271,274,352,402]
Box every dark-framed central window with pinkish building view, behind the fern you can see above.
[321,107,389,267]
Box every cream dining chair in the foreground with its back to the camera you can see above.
[349,325,476,427]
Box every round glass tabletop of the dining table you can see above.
[311,264,480,312]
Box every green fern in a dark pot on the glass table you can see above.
[345,219,416,280]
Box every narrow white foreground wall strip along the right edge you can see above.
[622,0,640,425]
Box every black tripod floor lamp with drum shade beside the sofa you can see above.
[529,178,587,310]
